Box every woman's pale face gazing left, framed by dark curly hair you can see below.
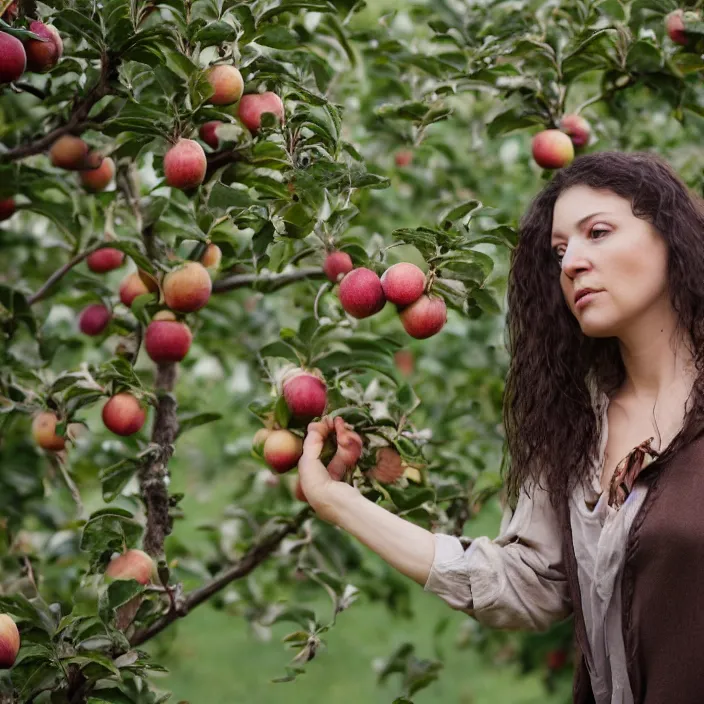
[551,186,669,337]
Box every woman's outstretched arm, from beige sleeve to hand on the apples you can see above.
[298,417,571,630]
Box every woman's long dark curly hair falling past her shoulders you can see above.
[503,152,704,506]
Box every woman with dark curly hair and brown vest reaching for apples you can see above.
[299,153,704,704]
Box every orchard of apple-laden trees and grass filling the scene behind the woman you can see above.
[0,0,704,704]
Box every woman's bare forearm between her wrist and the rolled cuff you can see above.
[325,483,435,585]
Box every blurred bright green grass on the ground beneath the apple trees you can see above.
[151,588,555,704]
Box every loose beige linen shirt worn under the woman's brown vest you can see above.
[424,393,660,704]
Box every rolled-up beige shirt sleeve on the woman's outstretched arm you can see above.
[424,487,572,631]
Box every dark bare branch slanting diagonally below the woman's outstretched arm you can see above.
[130,506,311,647]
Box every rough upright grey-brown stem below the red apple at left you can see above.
[139,363,178,558]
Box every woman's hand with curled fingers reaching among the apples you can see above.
[298,416,362,523]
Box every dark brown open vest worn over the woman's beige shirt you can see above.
[560,435,704,704]
